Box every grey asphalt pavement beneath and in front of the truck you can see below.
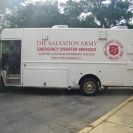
[0,87,133,133]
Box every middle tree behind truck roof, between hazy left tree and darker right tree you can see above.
[63,0,97,27]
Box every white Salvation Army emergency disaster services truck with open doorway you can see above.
[1,27,133,95]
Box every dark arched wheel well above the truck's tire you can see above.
[78,74,101,87]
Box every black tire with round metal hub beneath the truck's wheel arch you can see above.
[80,78,99,96]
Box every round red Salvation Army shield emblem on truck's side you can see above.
[104,40,124,60]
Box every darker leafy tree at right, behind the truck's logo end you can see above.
[81,0,133,27]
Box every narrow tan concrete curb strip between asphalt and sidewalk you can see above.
[78,96,133,133]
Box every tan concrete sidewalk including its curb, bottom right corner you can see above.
[79,96,133,133]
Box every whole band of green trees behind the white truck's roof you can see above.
[0,0,133,28]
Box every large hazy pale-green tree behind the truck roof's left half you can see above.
[6,1,62,27]
